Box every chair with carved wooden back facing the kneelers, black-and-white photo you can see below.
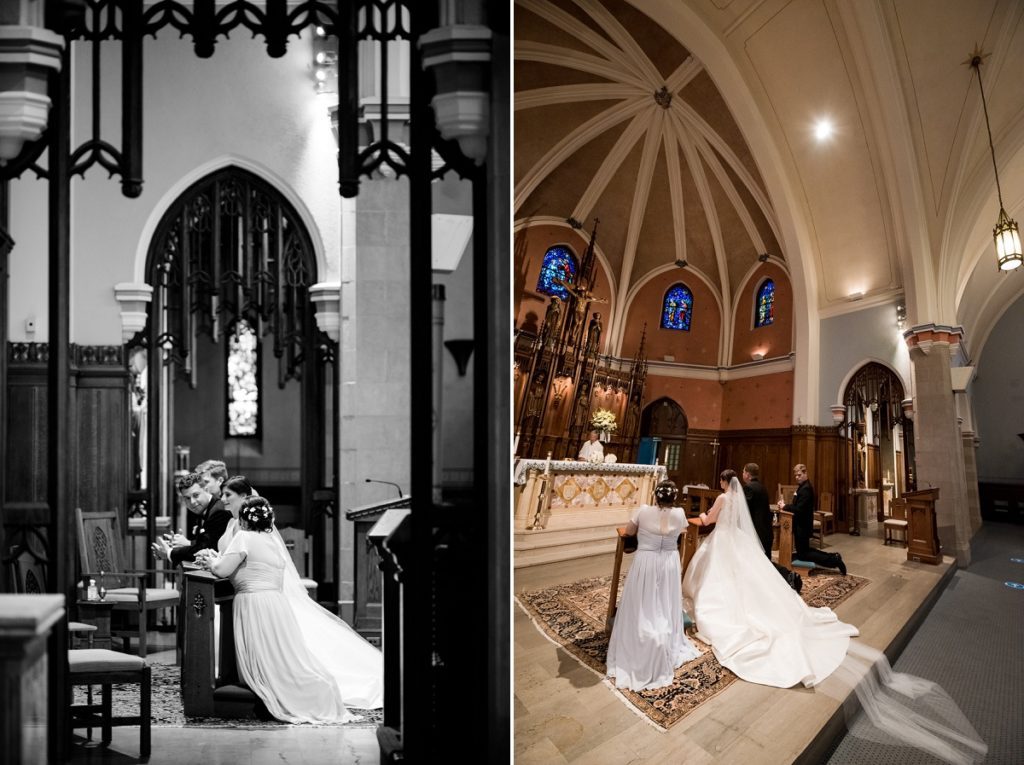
[75,507,178,657]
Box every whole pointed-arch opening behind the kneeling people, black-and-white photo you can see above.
[128,167,338,604]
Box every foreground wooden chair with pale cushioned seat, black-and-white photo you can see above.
[68,648,152,758]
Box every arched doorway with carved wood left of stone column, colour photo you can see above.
[837,362,916,533]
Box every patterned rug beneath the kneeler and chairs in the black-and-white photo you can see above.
[74,663,384,730]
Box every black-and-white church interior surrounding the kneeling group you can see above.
[0,0,511,763]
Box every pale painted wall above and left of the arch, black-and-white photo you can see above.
[9,31,341,344]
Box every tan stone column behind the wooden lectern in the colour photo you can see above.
[903,325,971,566]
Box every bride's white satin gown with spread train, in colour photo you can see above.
[683,478,858,688]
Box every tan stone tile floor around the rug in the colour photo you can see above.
[513,527,954,765]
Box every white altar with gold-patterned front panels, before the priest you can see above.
[513,460,668,567]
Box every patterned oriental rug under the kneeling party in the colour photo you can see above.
[516,572,869,730]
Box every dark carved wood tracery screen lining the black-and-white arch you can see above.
[140,167,337,597]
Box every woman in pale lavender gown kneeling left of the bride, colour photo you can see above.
[607,480,700,690]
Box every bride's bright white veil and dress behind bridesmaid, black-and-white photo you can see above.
[218,519,384,719]
